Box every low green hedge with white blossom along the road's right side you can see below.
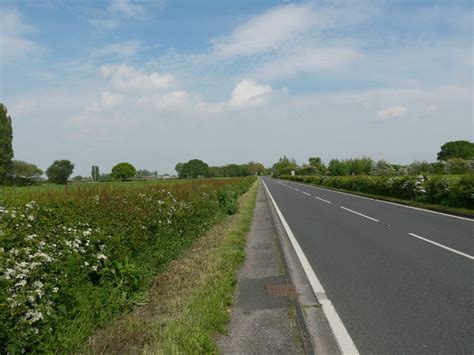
[281,174,474,209]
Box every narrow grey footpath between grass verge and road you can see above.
[218,184,312,354]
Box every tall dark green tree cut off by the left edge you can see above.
[0,103,13,184]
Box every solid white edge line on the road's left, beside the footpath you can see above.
[262,179,359,354]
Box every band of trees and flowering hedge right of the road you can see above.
[272,141,474,215]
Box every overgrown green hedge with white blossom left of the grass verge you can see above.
[0,177,255,353]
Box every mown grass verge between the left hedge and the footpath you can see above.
[81,181,258,354]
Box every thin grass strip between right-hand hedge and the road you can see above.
[289,180,474,218]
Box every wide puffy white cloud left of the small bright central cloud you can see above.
[101,64,174,91]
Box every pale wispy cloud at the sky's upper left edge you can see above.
[0,8,42,61]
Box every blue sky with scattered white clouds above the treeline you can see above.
[0,0,473,175]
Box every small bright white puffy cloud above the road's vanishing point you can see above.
[229,79,272,108]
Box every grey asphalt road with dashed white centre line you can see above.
[263,177,474,354]
